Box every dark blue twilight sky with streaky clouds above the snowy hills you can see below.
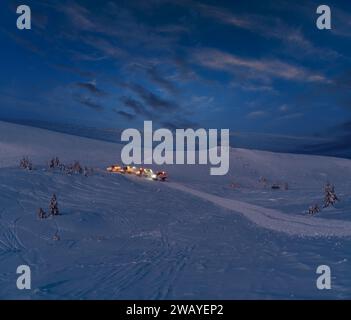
[0,0,351,156]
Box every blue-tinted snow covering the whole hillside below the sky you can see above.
[0,122,351,299]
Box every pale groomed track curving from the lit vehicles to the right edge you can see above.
[165,182,351,237]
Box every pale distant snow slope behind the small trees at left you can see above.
[0,121,120,167]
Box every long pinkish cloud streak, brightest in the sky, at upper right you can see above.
[192,48,329,83]
